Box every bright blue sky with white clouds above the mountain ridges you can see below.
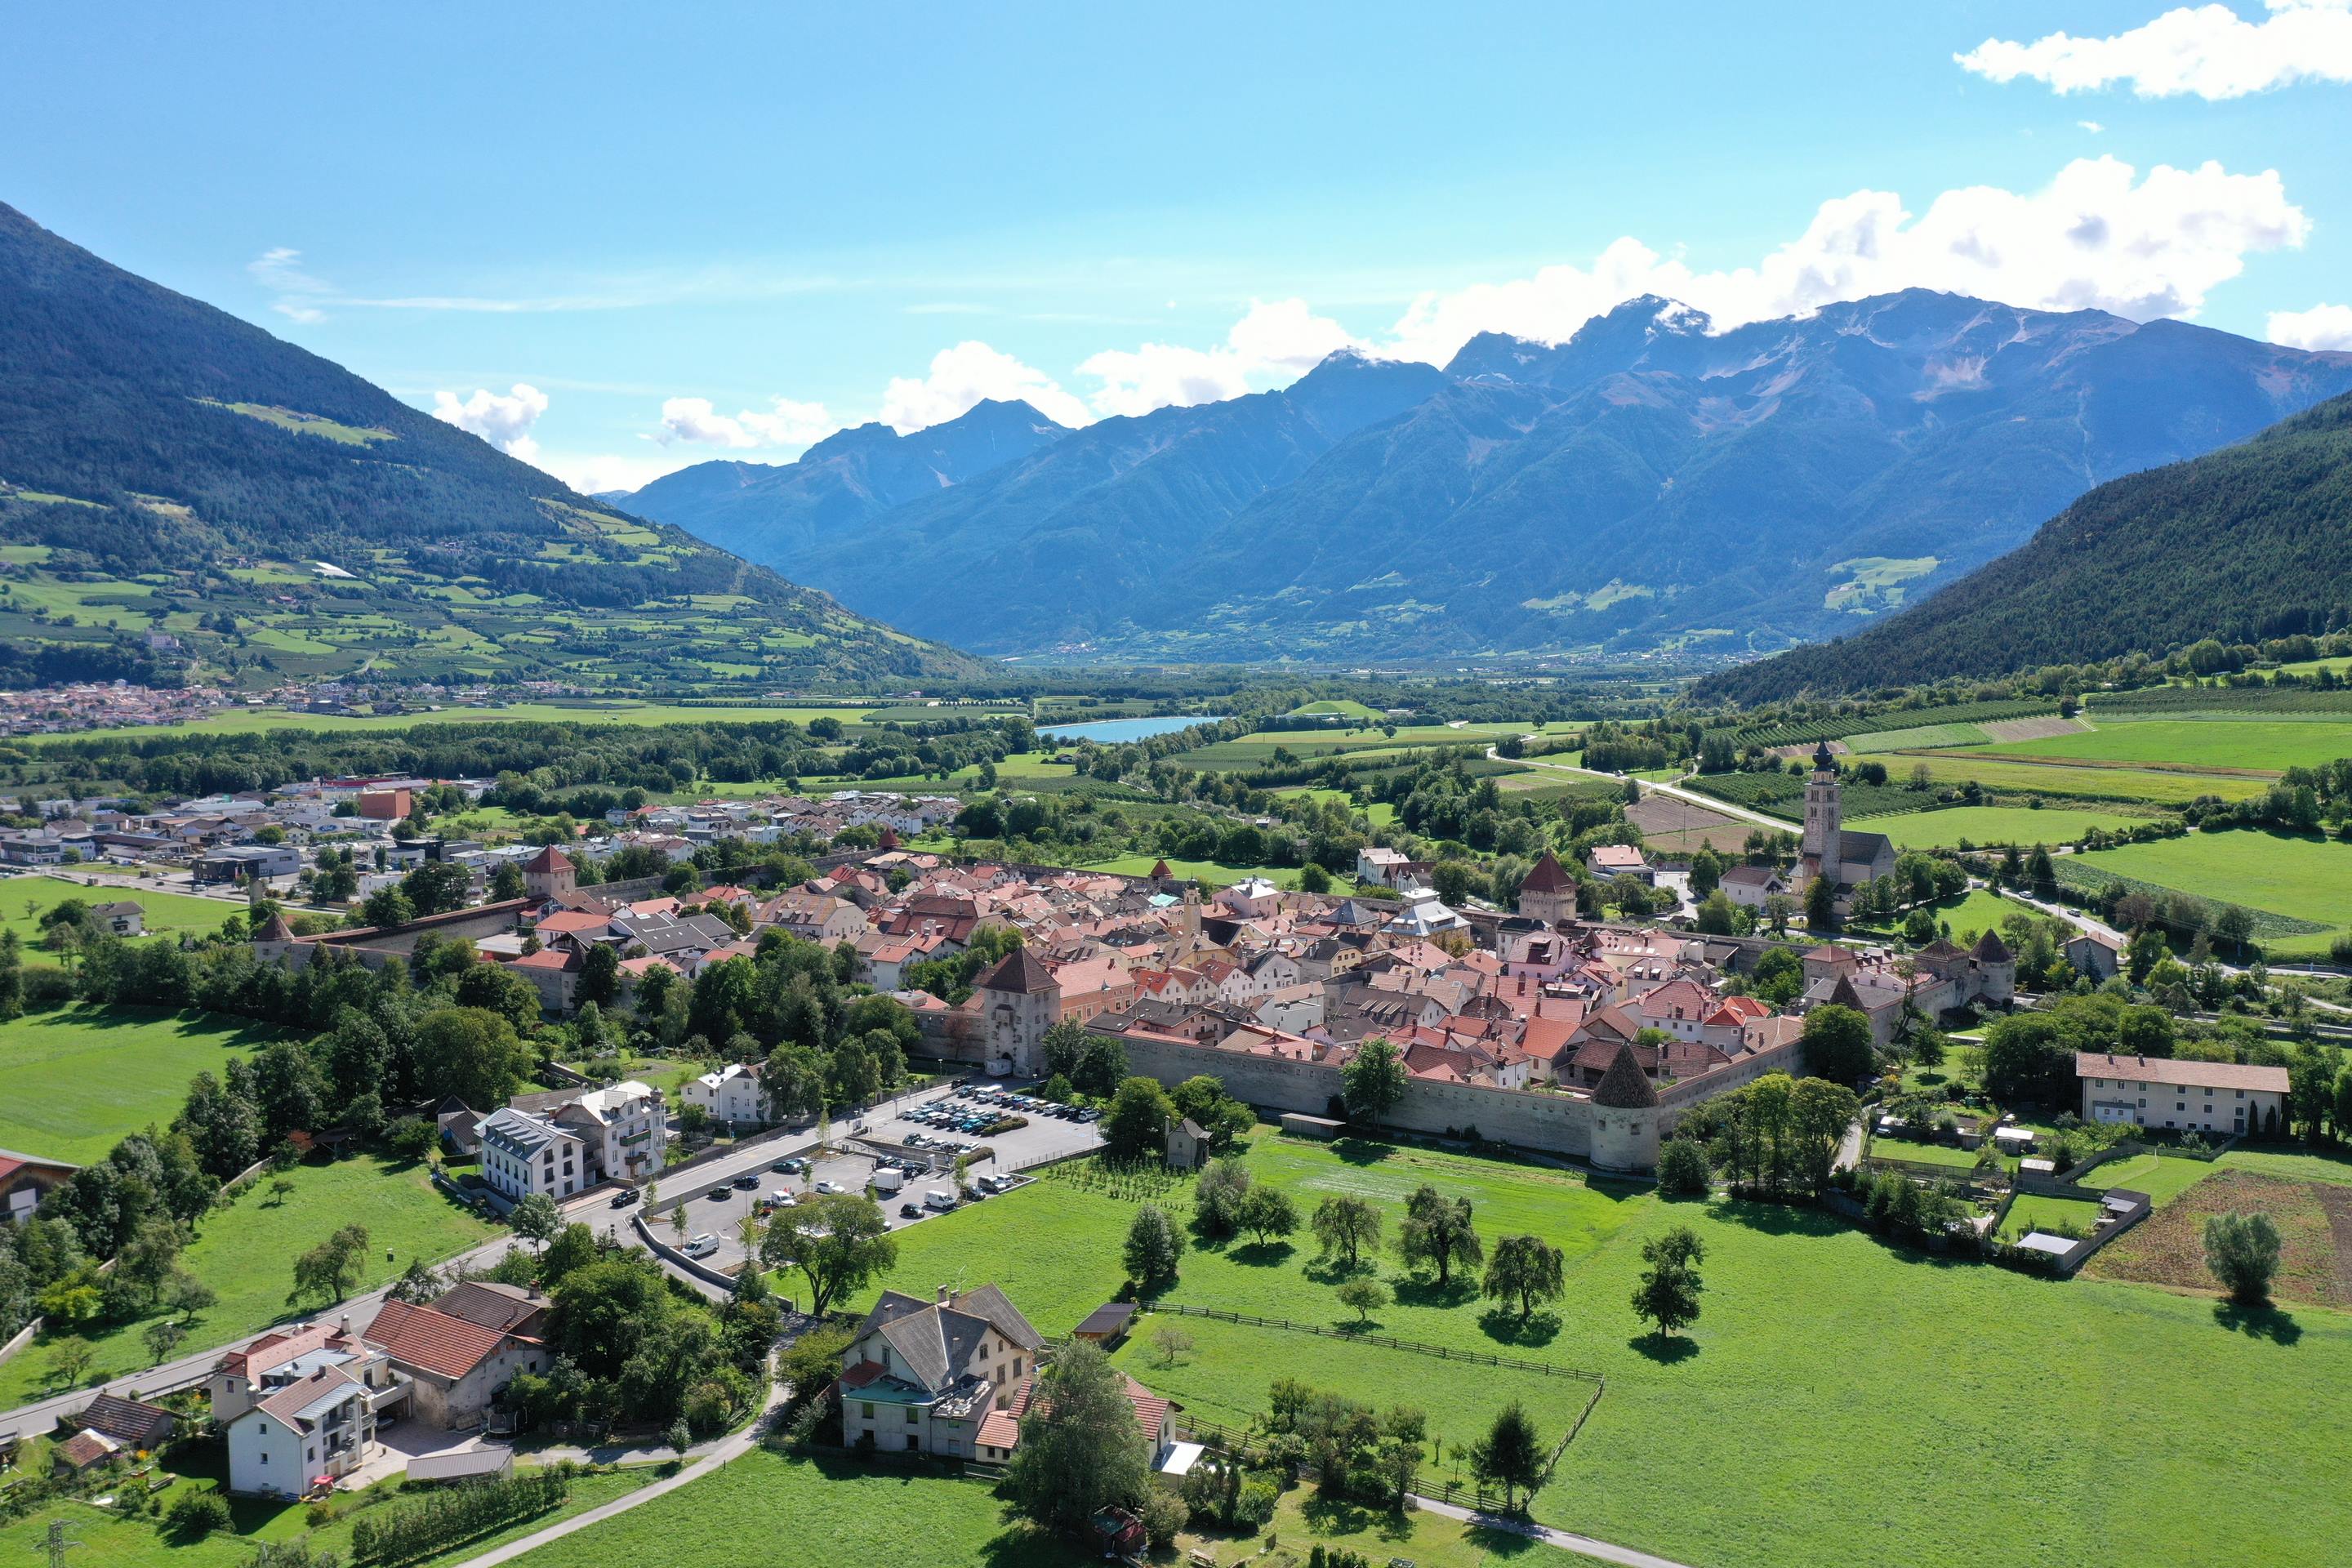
[13,0,2352,487]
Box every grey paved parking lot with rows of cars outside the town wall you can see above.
[648,1081,1103,1290]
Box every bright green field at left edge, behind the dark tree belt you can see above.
[0,1006,278,1166]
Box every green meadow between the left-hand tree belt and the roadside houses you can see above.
[0,1154,497,1410]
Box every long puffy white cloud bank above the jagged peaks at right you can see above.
[1383,158,2310,364]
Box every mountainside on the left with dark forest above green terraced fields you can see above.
[0,204,981,687]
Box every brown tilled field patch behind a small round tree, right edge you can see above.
[2084,1161,2352,1307]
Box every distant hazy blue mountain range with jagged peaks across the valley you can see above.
[628,289,2352,658]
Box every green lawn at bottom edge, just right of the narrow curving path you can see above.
[515,1448,1091,1568]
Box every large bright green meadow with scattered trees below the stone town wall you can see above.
[865,1138,2352,1568]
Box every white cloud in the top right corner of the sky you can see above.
[1952,0,2352,99]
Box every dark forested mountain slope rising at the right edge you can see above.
[1698,397,2352,703]
